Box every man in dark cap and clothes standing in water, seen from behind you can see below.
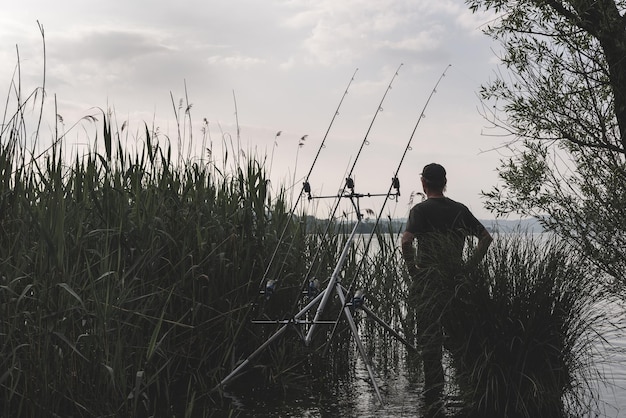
[402,163,492,407]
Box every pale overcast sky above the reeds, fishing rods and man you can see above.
[0,0,502,219]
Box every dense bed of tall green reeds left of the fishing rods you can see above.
[0,99,322,416]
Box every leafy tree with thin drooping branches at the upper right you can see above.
[466,0,626,286]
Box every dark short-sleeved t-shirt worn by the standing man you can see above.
[406,197,485,267]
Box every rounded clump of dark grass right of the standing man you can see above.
[438,234,602,418]
